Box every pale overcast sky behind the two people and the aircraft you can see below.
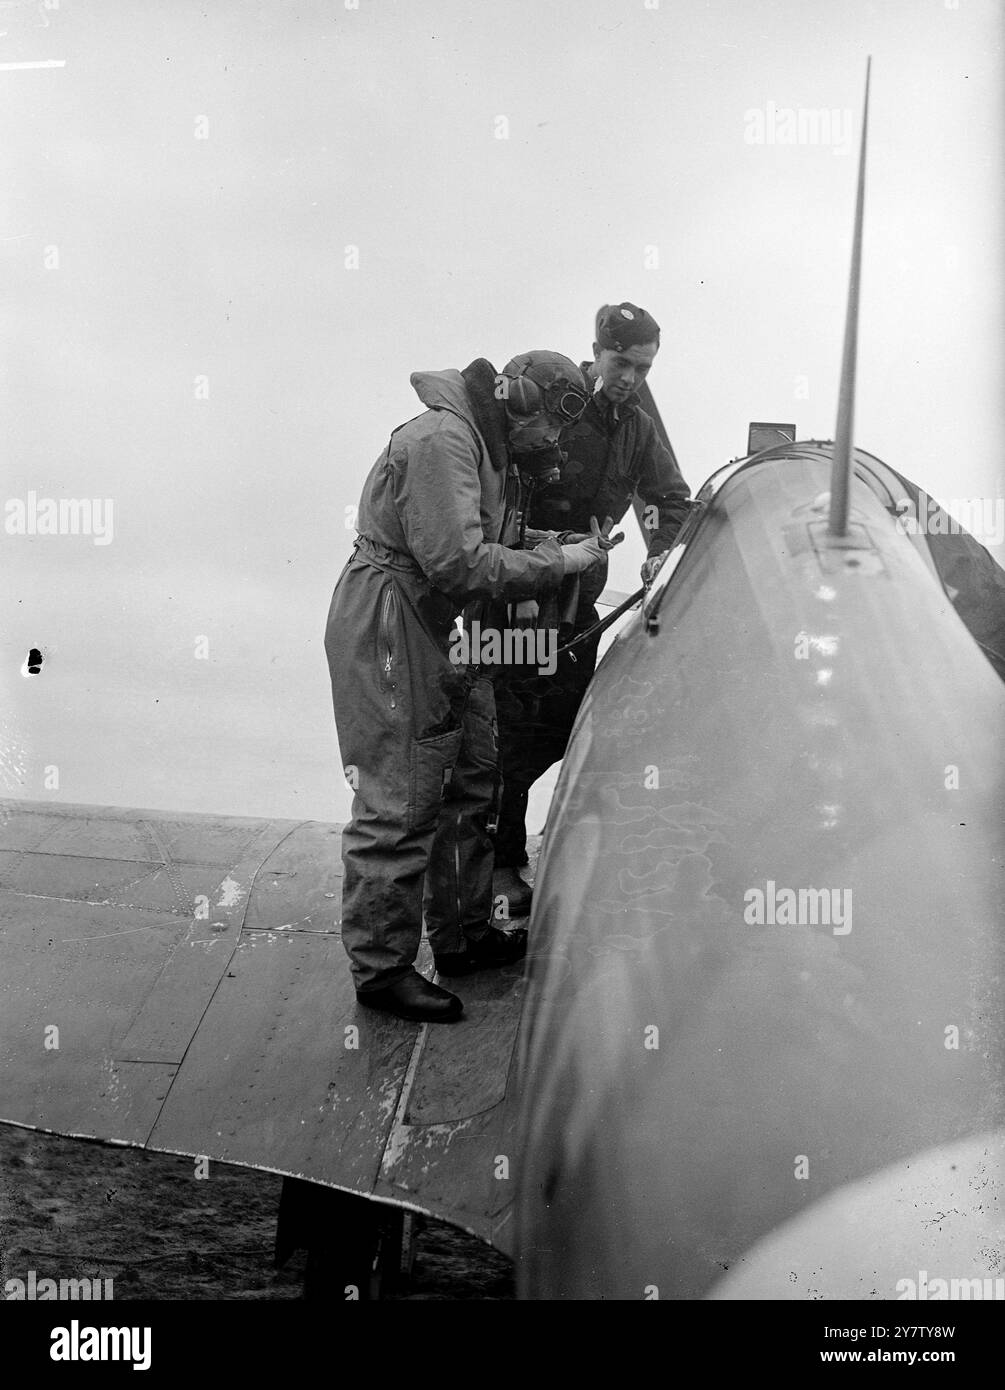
[0,0,1005,830]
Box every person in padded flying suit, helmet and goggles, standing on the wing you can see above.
[325,352,605,1023]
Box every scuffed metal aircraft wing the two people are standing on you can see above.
[0,801,523,1250]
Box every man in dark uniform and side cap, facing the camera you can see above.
[492,303,691,916]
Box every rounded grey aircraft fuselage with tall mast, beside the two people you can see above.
[517,446,1005,1298]
